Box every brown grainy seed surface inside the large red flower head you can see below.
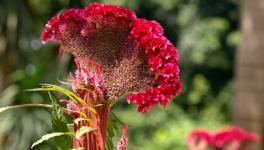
[60,24,154,100]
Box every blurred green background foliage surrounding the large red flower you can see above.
[0,0,241,150]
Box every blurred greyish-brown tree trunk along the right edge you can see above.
[233,0,264,150]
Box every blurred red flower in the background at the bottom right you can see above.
[186,127,258,150]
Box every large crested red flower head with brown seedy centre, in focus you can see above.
[42,3,181,112]
